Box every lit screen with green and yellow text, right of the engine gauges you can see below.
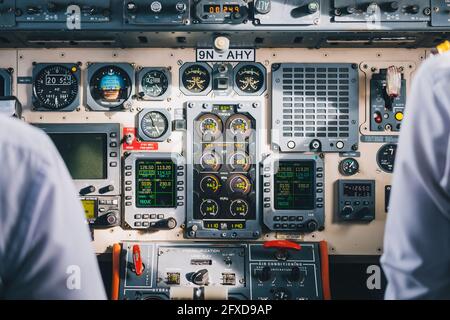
[274,160,315,210]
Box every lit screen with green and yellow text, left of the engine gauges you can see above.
[136,159,177,208]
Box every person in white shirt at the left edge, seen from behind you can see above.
[0,115,106,299]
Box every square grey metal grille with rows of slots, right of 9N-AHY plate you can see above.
[272,64,358,151]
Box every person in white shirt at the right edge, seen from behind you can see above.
[381,53,450,299]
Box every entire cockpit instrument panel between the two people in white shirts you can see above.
[0,0,442,299]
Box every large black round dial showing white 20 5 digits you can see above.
[33,65,78,110]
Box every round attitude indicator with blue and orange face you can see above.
[89,65,131,108]
